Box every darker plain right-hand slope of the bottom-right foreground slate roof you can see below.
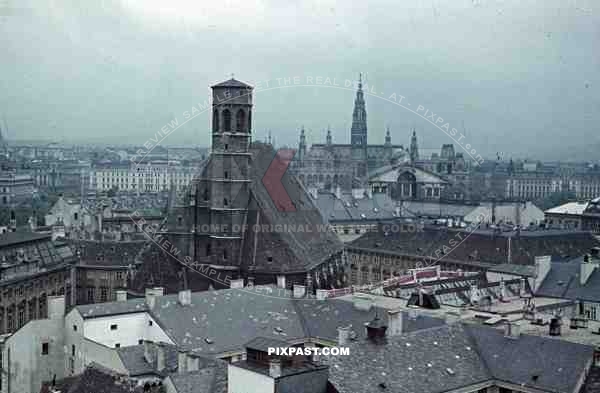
[465,325,594,392]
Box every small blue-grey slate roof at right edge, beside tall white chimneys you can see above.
[536,258,600,302]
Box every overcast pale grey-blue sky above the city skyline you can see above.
[0,0,600,160]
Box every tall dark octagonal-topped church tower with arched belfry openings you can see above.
[204,78,253,266]
